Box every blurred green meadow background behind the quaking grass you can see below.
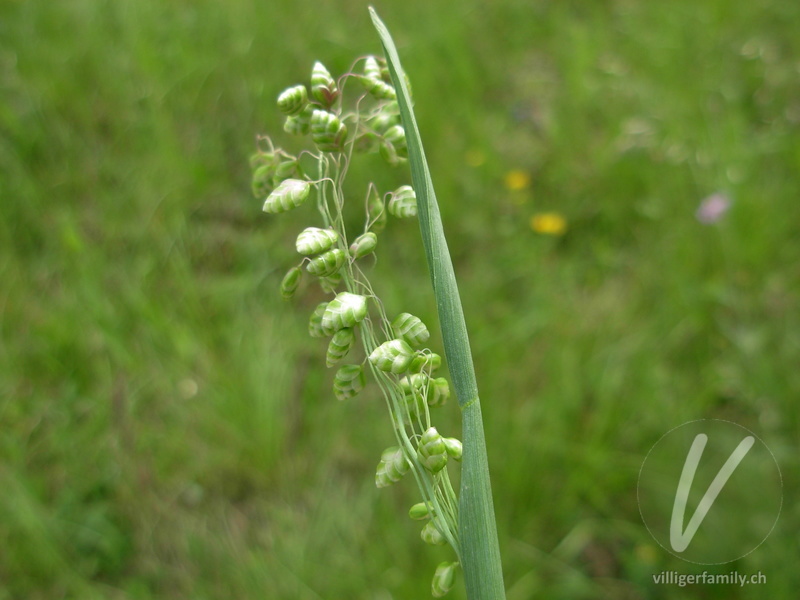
[0,0,800,600]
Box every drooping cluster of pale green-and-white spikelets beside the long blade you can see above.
[250,44,469,597]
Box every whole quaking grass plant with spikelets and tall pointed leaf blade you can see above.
[251,8,505,600]
